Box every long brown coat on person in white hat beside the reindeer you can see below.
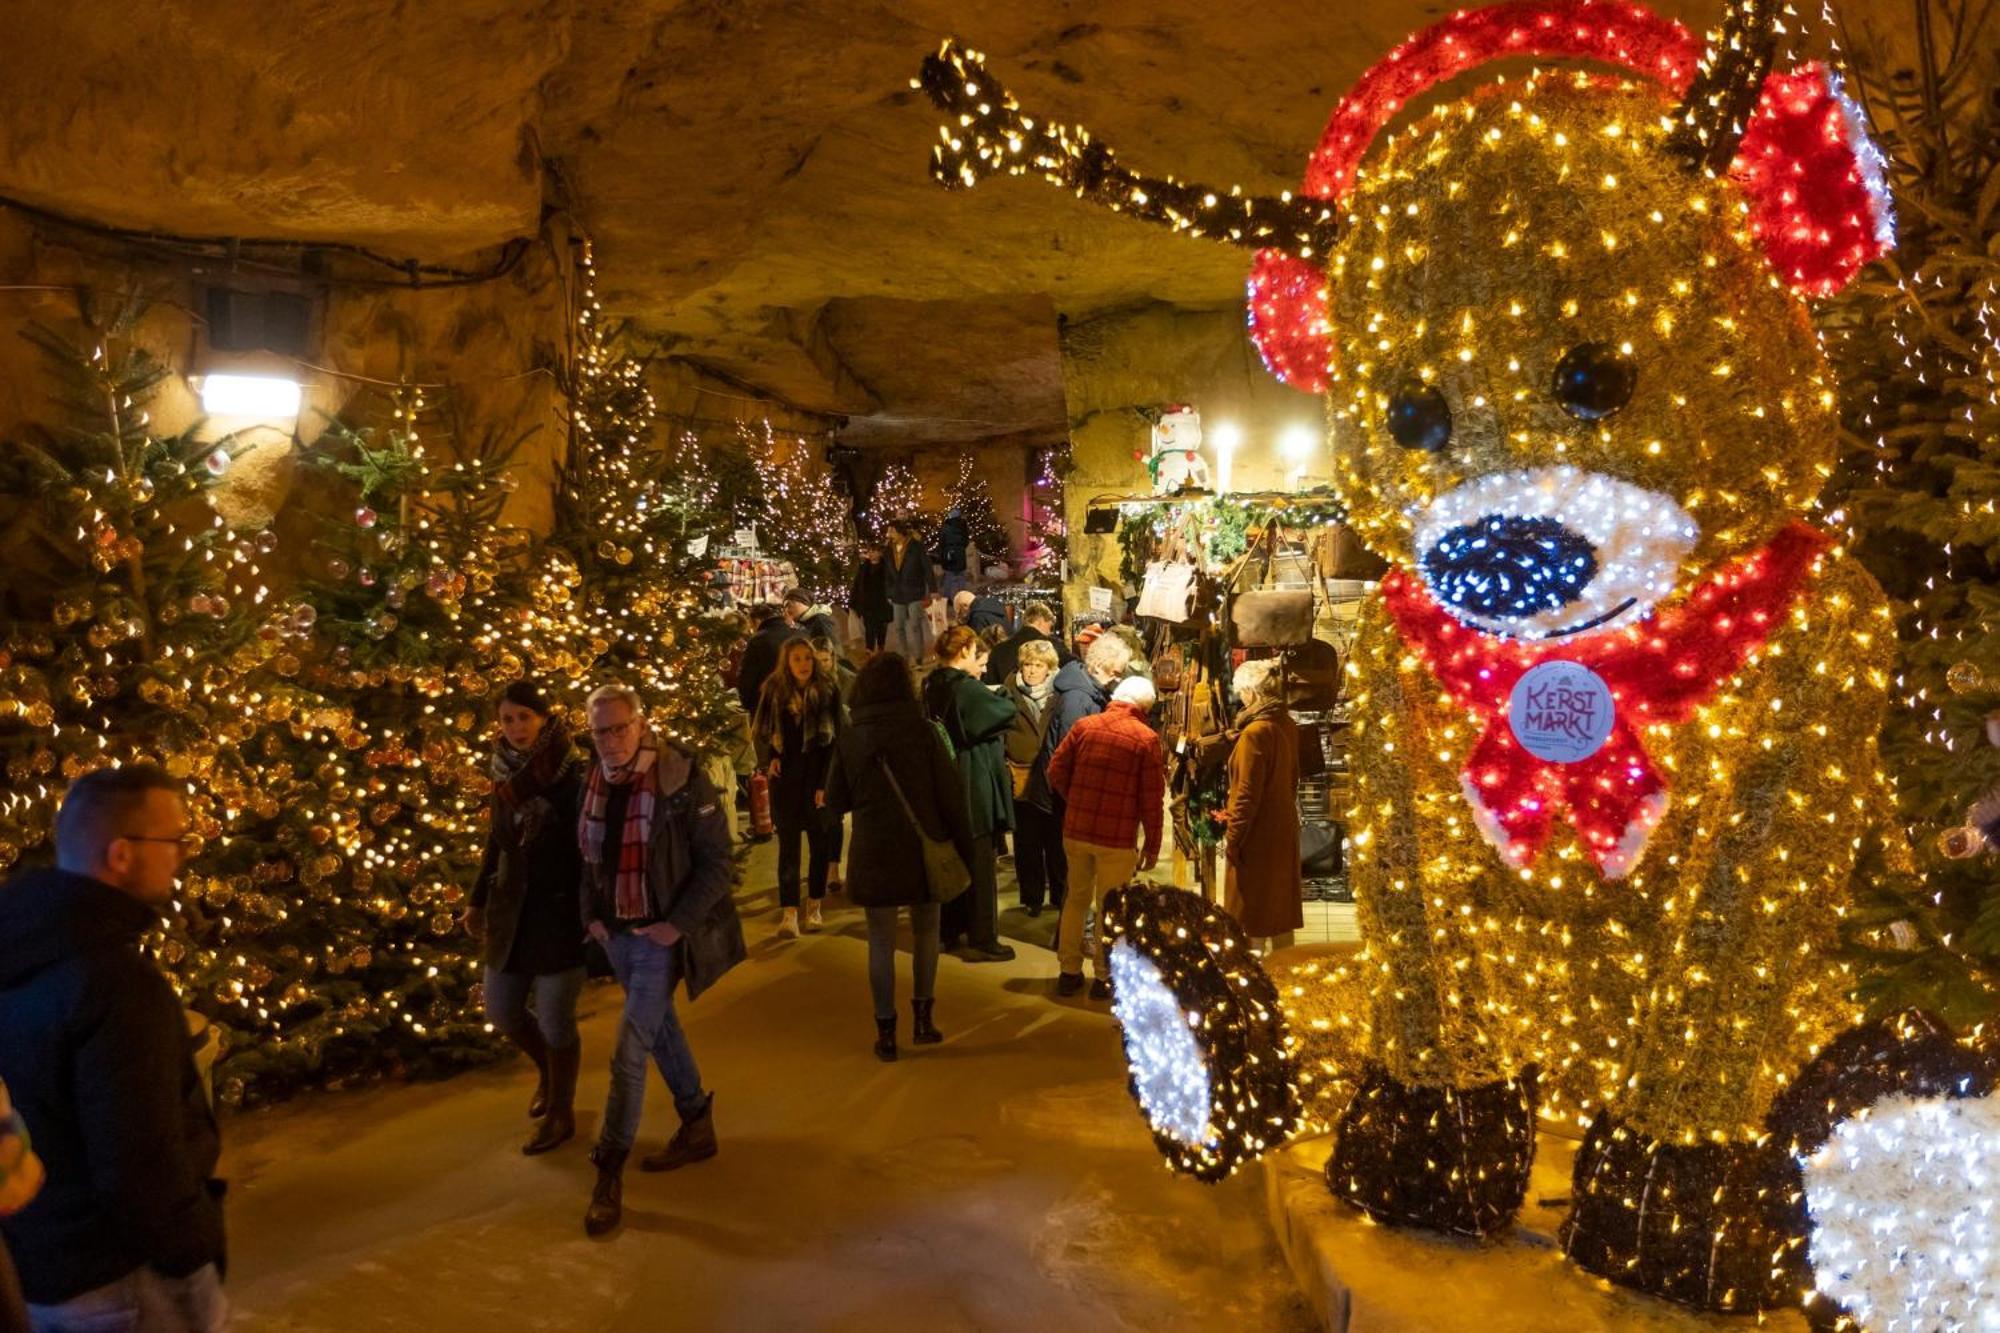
[1222,703,1306,935]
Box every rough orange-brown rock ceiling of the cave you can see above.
[0,0,1824,446]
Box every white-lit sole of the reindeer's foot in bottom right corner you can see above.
[1804,1097,2000,1333]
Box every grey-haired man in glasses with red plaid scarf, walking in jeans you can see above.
[576,685,744,1235]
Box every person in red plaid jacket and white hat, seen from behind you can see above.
[1048,677,1166,999]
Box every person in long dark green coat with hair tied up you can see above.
[924,624,1014,963]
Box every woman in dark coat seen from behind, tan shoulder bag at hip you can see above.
[826,652,972,1061]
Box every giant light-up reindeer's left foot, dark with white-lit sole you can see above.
[1104,885,1298,1181]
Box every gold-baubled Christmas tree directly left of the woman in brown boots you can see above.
[210,392,560,1101]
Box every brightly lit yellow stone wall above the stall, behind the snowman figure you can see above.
[1062,304,1326,614]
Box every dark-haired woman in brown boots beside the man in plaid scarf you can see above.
[466,681,584,1155]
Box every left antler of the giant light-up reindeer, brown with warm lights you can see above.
[912,38,1340,258]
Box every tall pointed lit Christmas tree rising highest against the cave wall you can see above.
[550,244,730,753]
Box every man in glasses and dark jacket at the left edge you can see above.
[0,765,228,1333]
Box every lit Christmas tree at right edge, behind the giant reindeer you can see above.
[1826,0,2000,1025]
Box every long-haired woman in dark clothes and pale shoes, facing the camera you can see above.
[750,638,844,939]
